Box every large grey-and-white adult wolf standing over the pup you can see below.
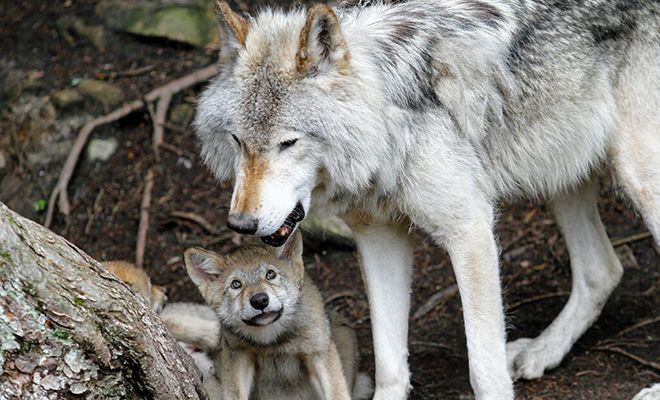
[195,0,660,400]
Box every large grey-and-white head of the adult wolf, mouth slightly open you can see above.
[195,2,386,246]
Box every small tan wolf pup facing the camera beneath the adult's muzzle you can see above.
[185,233,374,400]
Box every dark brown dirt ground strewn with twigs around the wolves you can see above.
[0,0,660,400]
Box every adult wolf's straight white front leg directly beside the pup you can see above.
[354,227,412,400]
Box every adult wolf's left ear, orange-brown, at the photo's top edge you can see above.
[215,1,250,65]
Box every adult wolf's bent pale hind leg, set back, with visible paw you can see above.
[507,180,623,379]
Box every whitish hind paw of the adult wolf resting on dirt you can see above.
[506,338,548,379]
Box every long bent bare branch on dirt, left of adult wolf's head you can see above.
[44,64,218,228]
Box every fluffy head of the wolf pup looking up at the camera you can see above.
[185,232,305,345]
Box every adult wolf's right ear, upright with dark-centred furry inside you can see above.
[296,4,350,76]
